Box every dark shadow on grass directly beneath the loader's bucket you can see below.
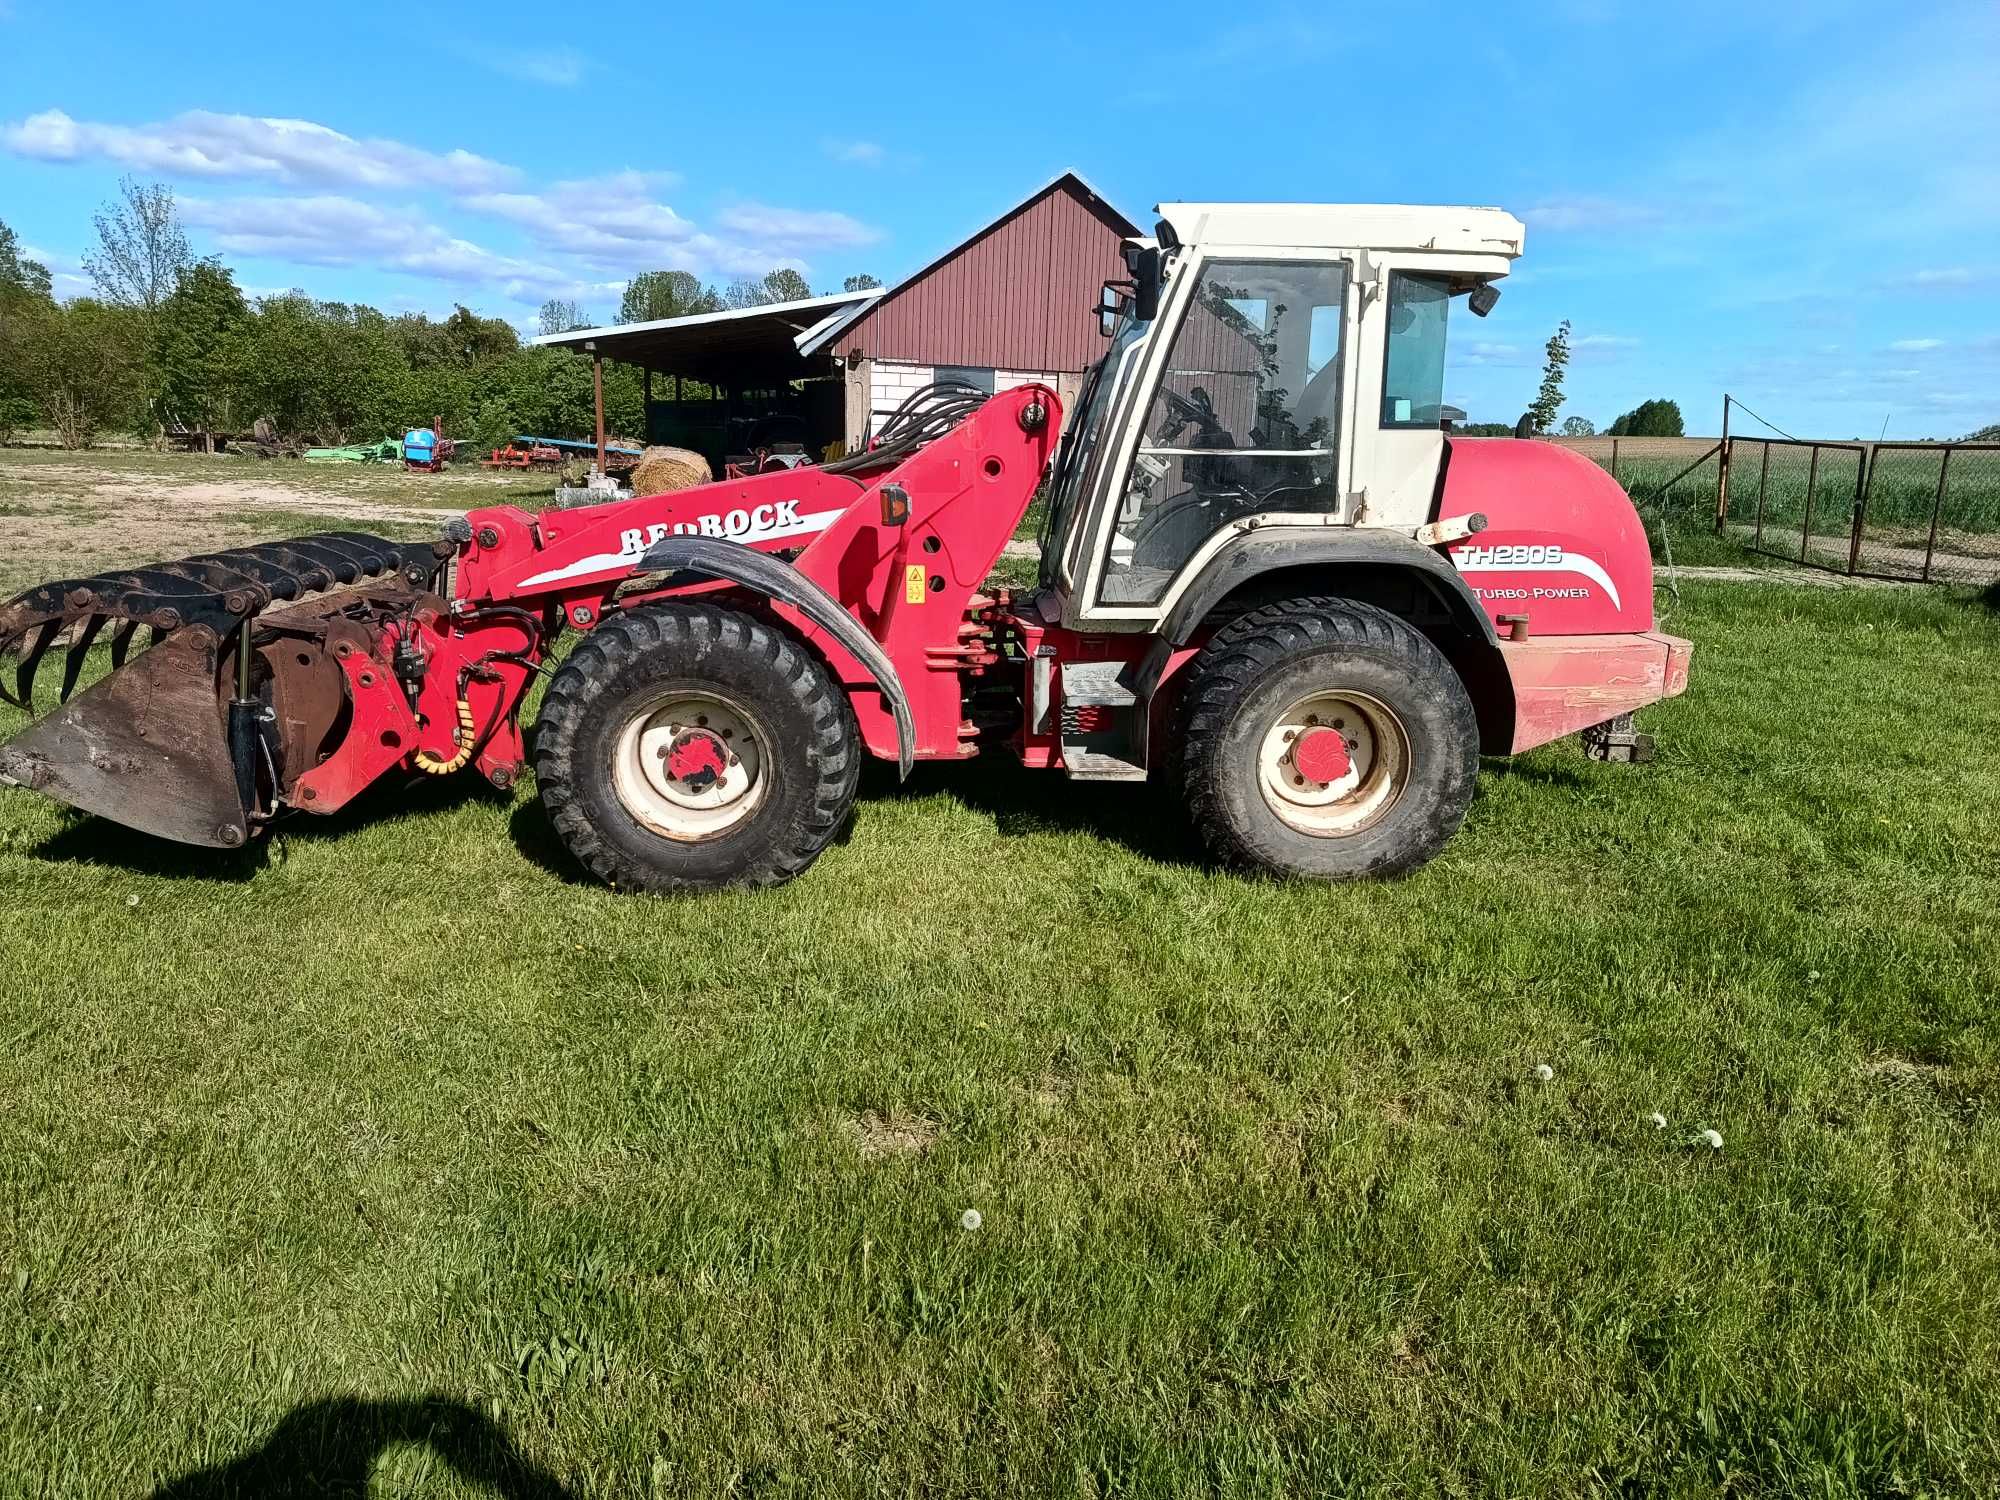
[28,776,510,882]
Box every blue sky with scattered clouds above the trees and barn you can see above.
[0,0,2000,438]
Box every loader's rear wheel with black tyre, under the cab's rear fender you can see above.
[1174,596,1478,880]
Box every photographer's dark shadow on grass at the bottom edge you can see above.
[152,1396,572,1500]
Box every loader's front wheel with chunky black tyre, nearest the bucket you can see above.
[534,604,862,892]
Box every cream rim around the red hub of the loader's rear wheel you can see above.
[1258,690,1410,838]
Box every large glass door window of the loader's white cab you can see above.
[1100,260,1348,604]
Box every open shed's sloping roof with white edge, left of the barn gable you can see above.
[528,286,884,386]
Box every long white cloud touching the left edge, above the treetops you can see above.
[0,110,518,192]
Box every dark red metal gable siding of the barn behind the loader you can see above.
[834,182,1126,370]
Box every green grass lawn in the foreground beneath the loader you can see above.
[0,540,2000,1496]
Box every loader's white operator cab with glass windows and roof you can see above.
[1042,204,1524,630]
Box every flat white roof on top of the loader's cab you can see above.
[1158,204,1526,260]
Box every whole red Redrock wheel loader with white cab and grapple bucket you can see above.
[0,204,1690,890]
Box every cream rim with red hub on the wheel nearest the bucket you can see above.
[612,692,770,844]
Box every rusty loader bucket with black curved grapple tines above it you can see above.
[0,532,450,848]
